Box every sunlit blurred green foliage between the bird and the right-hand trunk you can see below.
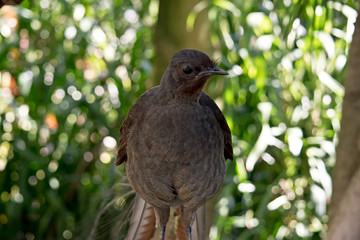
[205,0,357,239]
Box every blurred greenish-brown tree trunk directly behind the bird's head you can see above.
[150,0,211,86]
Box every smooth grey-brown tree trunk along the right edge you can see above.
[327,7,360,240]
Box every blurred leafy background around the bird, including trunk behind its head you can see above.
[0,0,357,240]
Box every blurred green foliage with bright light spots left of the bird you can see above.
[0,0,157,239]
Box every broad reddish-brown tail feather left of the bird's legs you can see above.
[126,194,156,240]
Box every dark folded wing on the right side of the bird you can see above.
[199,92,234,161]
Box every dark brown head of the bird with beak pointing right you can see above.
[161,49,228,99]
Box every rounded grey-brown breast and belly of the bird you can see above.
[126,102,225,209]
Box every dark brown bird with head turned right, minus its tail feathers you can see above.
[115,49,234,240]
